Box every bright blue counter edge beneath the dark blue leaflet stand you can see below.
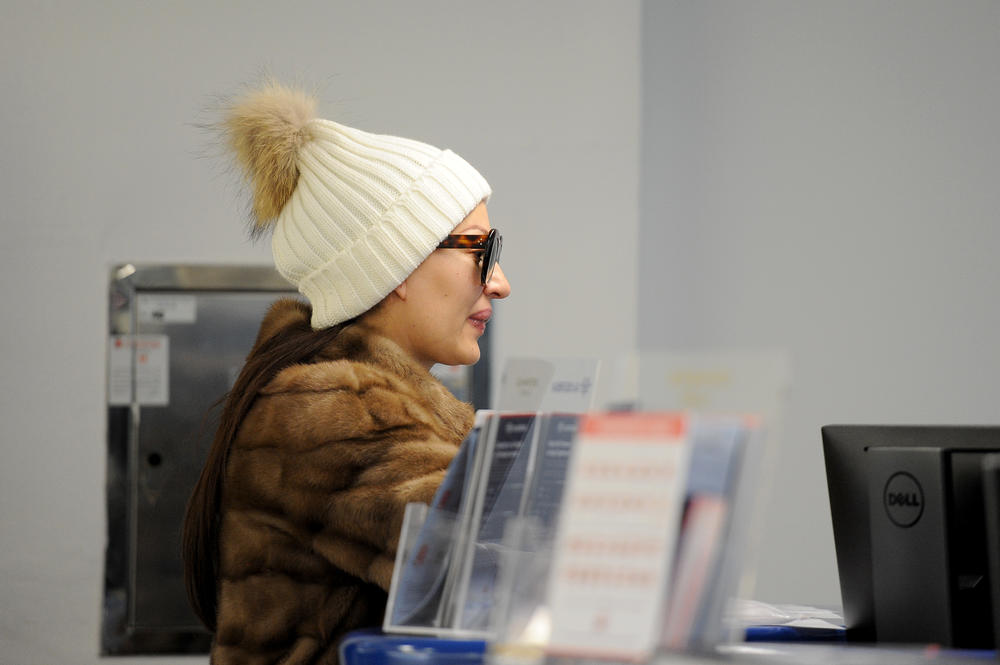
[340,629,486,665]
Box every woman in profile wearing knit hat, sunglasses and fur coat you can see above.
[183,82,510,665]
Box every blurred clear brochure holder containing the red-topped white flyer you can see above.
[491,413,765,662]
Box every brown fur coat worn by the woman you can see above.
[212,301,473,665]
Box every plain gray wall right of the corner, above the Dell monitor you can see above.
[638,0,1000,604]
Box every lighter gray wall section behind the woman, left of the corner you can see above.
[0,0,640,665]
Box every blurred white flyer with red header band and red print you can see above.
[548,413,689,661]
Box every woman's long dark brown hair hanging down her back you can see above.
[181,303,353,632]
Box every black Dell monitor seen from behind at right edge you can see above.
[822,425,1000,648]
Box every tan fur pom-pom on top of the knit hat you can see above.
[224,81,316,235]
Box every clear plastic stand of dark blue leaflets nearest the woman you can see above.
[383,412,579,639]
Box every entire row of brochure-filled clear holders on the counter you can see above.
[383,412,766,662]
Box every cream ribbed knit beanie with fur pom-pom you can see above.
[225,82,490,329]
